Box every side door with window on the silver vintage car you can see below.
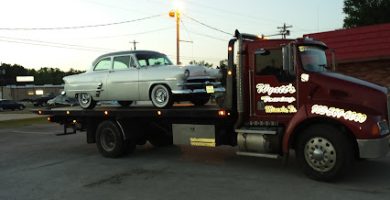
[107,55,139,101]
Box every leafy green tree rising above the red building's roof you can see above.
[343,0,390,28]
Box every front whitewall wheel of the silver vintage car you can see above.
[150,84,173,108]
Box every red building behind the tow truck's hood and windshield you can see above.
[304,23,390,87]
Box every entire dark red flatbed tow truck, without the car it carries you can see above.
[33,31,390,181]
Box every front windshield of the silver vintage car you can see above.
[135,53,172,67]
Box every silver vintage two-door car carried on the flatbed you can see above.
[63,51,225,109]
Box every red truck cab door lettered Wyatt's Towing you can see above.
[249,47,297,124]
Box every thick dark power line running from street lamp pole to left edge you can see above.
[0,14,162,31]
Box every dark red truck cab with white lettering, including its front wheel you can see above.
[225,31,390,180]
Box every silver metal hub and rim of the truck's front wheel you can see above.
[304,137,336,172]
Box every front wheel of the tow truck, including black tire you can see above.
[296,124,354,181]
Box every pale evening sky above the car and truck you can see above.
[0,0,344,70]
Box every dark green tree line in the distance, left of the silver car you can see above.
[0,63,84,85]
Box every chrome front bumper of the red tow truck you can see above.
[357,135,390,158]
